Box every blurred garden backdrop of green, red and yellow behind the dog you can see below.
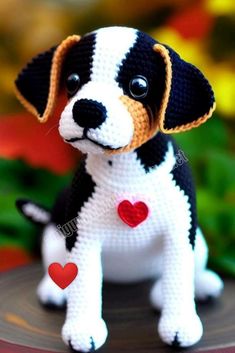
[0,0,235,276]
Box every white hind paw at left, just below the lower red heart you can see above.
[37,275,66,309]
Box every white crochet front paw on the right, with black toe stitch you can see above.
[158,313,203,347]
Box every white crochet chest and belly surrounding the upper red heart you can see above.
[73,143,191,281]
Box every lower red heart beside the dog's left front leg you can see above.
[48,262,78,289]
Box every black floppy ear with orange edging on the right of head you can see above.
[154,43,215,133]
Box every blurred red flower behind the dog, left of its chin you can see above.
[0,95,80,174]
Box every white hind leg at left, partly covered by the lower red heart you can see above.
[37,223,66,308]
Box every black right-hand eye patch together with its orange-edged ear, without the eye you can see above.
[116,28,215,133]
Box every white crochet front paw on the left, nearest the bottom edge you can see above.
[62,319,108,352]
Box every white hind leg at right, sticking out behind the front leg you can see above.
[195,228,223,300]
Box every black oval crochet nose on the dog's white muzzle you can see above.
[73,99,107,129]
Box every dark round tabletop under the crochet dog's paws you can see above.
[0,264,235,353]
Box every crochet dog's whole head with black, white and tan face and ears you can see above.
[16,27,215,153]
